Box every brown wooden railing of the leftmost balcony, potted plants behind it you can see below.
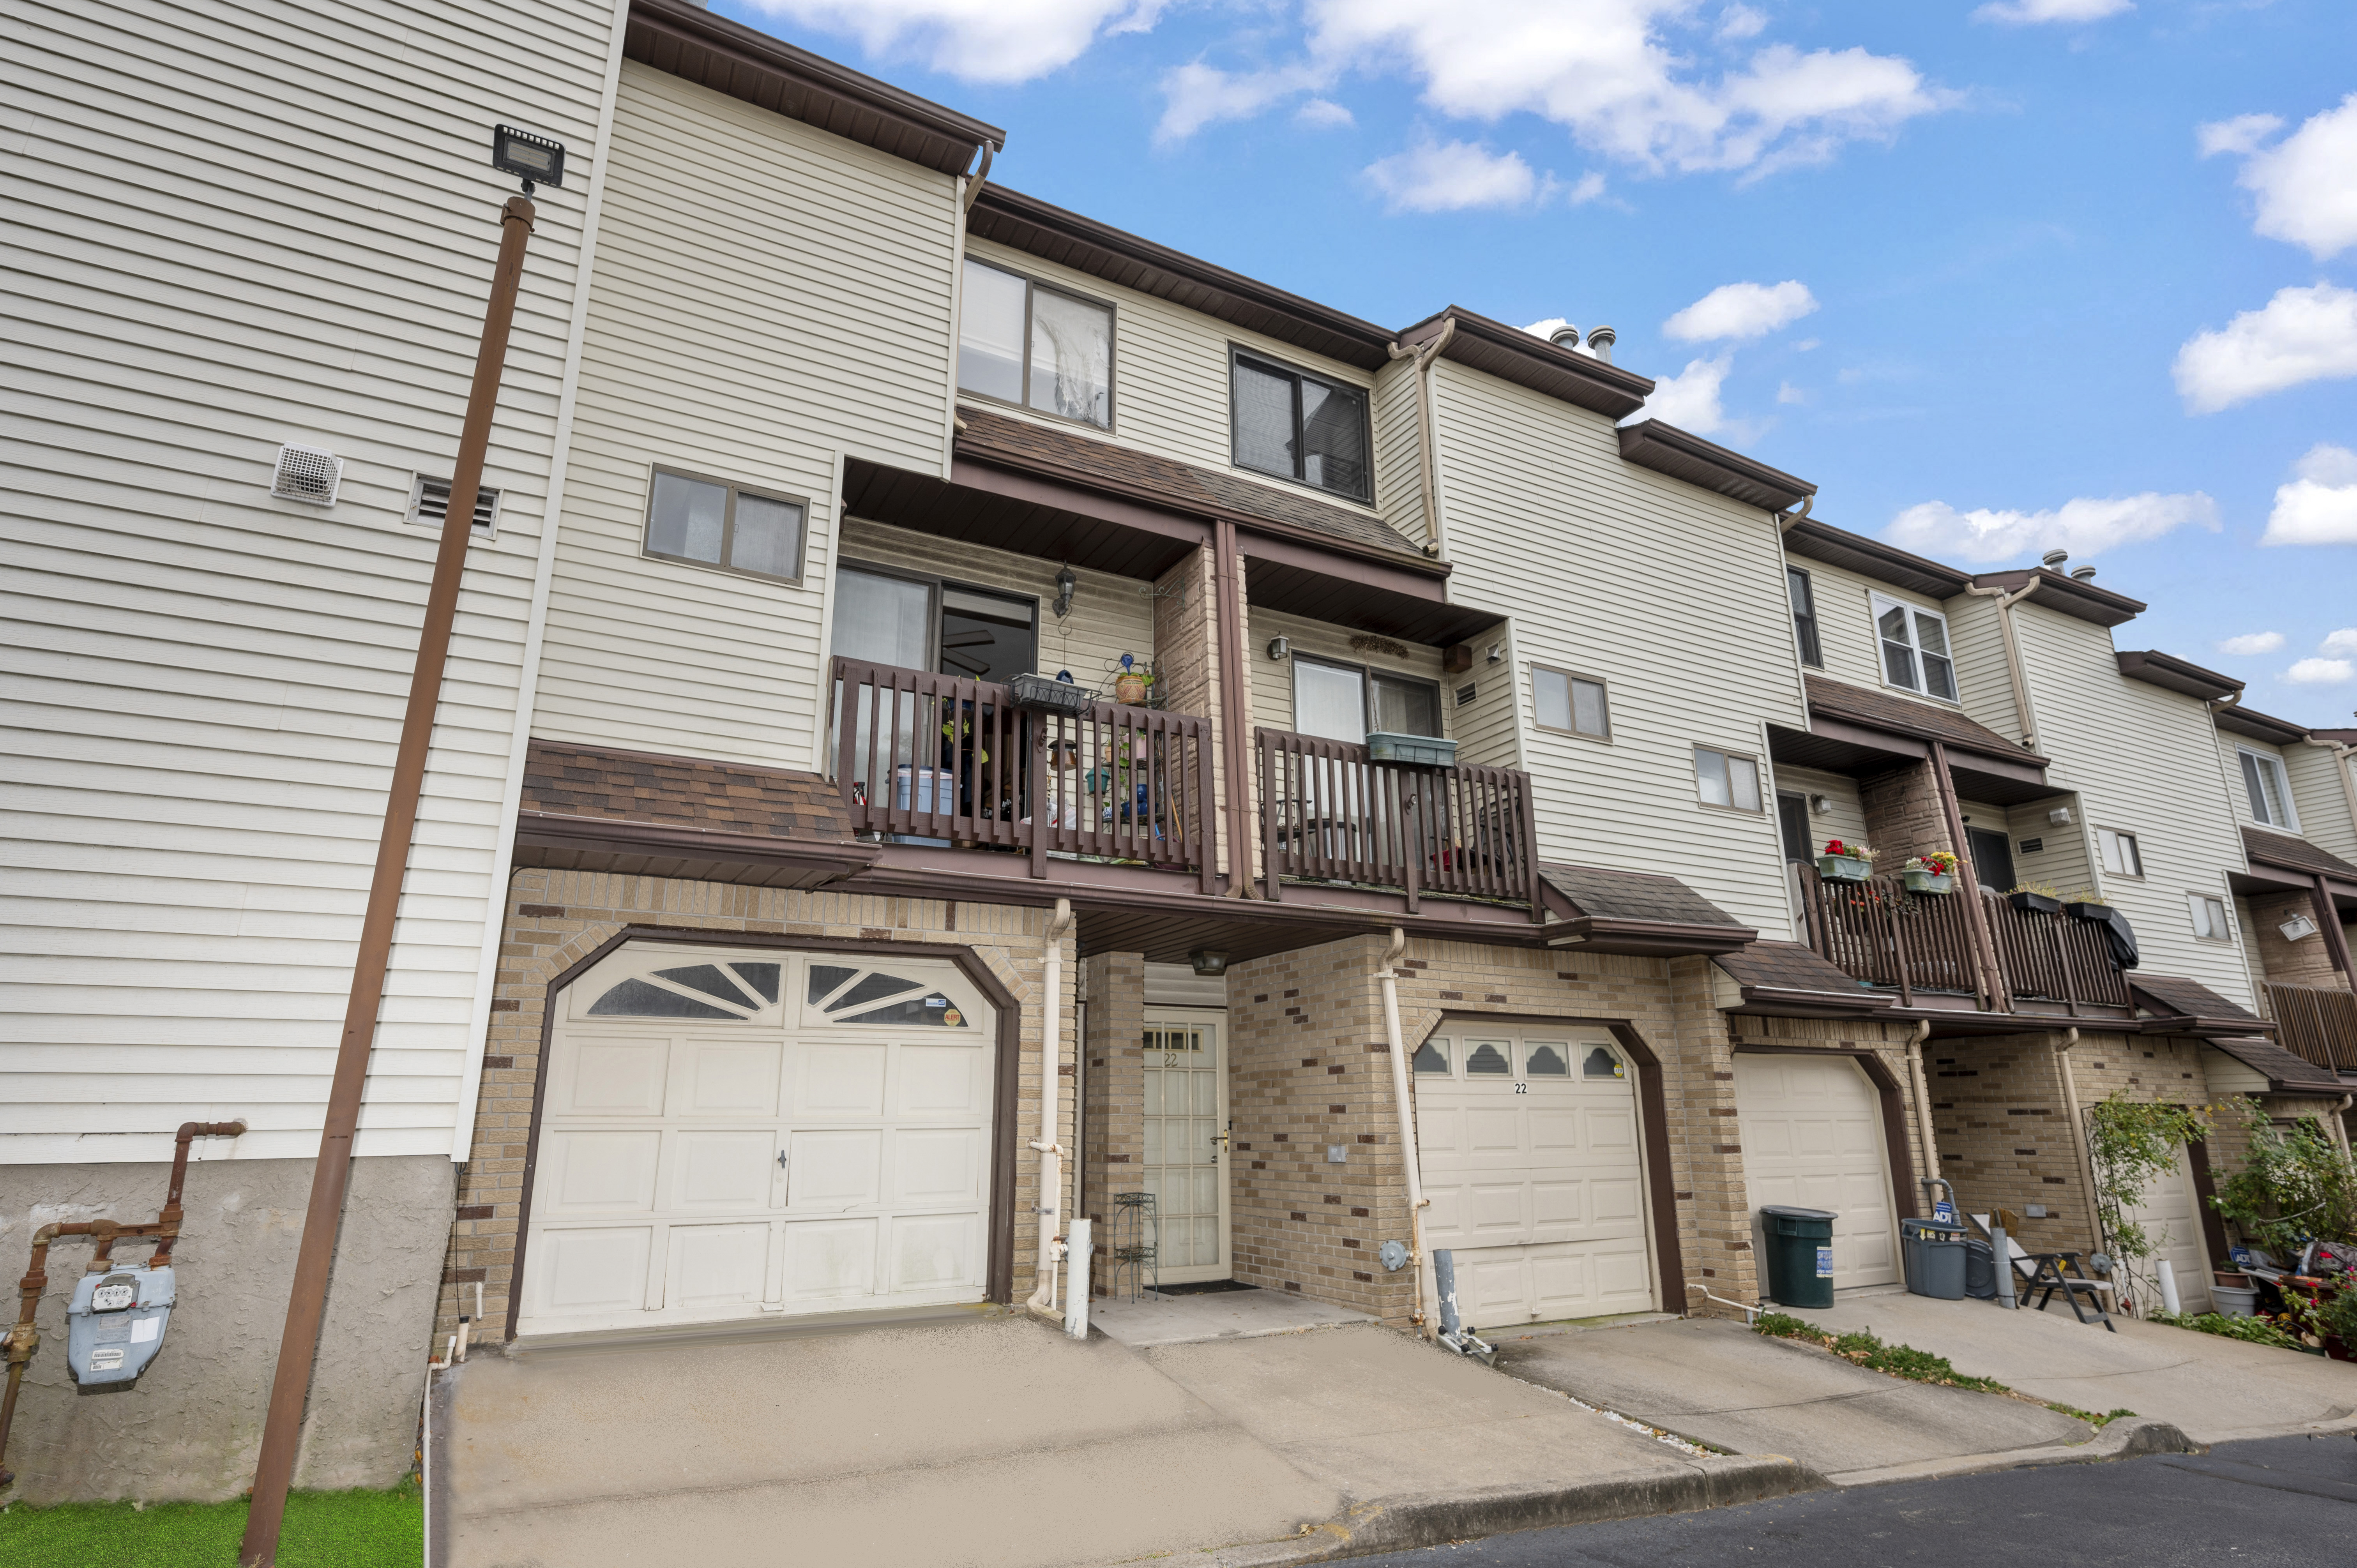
[830,658,1219,893]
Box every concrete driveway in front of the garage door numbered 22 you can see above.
[1497,1318,2096,1485]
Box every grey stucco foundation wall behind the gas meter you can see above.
[0,1155,455,1509]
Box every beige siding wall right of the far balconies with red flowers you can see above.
[2013,604,2253,1007]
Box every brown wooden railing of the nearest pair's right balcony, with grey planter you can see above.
[1254,729,1544,920]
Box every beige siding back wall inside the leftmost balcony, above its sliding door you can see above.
[841,516,1155,700]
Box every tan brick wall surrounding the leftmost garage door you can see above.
[434,868,1080,1342]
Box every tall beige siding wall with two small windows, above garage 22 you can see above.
[1435,361,1806,931]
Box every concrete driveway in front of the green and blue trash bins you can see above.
[1794,1294,2357,1443]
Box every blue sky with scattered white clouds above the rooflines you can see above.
[714,0,2357,726]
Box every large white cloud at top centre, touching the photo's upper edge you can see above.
[1159,0,1954,175]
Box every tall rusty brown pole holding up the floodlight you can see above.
[238,196,539,1568]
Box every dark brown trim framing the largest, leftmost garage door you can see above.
[507,924,1023,1339]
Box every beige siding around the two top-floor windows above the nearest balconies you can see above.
[966,236,1417,507]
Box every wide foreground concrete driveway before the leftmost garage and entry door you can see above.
[436,1316,1810,1568]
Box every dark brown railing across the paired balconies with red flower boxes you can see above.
[1794,865,2128,1009]
